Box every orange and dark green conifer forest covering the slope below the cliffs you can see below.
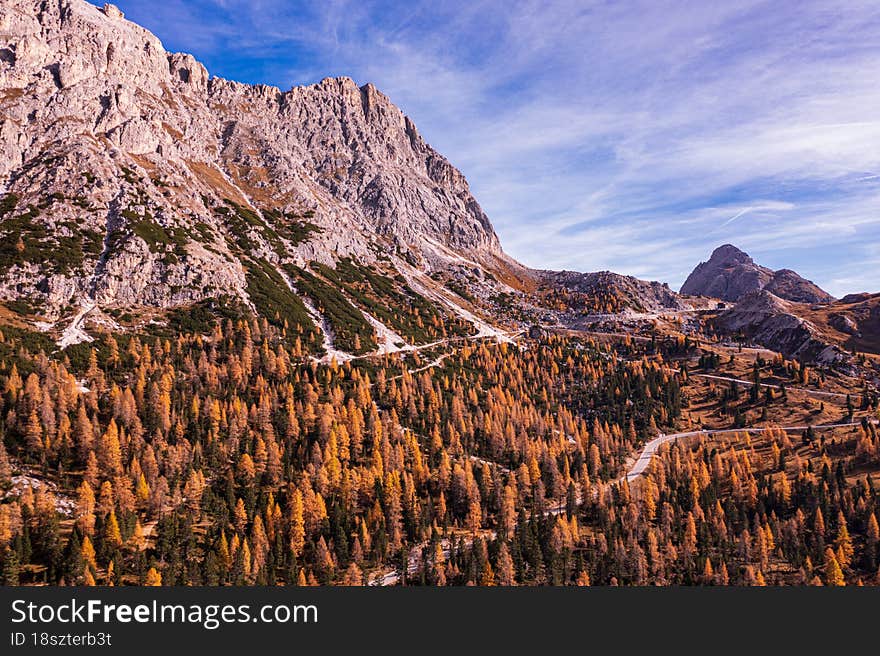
[0,318,880,585]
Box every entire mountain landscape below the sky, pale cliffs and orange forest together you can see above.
[0,0,880,585]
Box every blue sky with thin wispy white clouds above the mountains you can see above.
[105,0,880,295]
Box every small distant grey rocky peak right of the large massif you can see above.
[681,244,834,303]
